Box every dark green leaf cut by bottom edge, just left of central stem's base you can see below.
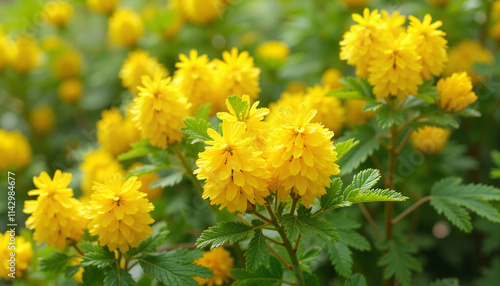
[231,256,283,286]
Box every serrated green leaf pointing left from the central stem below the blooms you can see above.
[196,222,260,248]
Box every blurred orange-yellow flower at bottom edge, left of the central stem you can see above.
[193,247,234,286]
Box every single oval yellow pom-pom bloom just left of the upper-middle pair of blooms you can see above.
[131,73,191,149]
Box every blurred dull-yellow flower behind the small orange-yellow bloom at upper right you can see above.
[444,40,493,84]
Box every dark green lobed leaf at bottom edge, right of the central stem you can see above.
[378,240,422,286]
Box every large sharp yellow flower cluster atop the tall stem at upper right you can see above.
[340,9,448,100]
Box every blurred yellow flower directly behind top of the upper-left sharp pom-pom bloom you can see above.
[119,49,168,94]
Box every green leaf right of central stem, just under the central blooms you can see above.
[280,213,339,241]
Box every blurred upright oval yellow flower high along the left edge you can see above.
[12,36,42,73]
